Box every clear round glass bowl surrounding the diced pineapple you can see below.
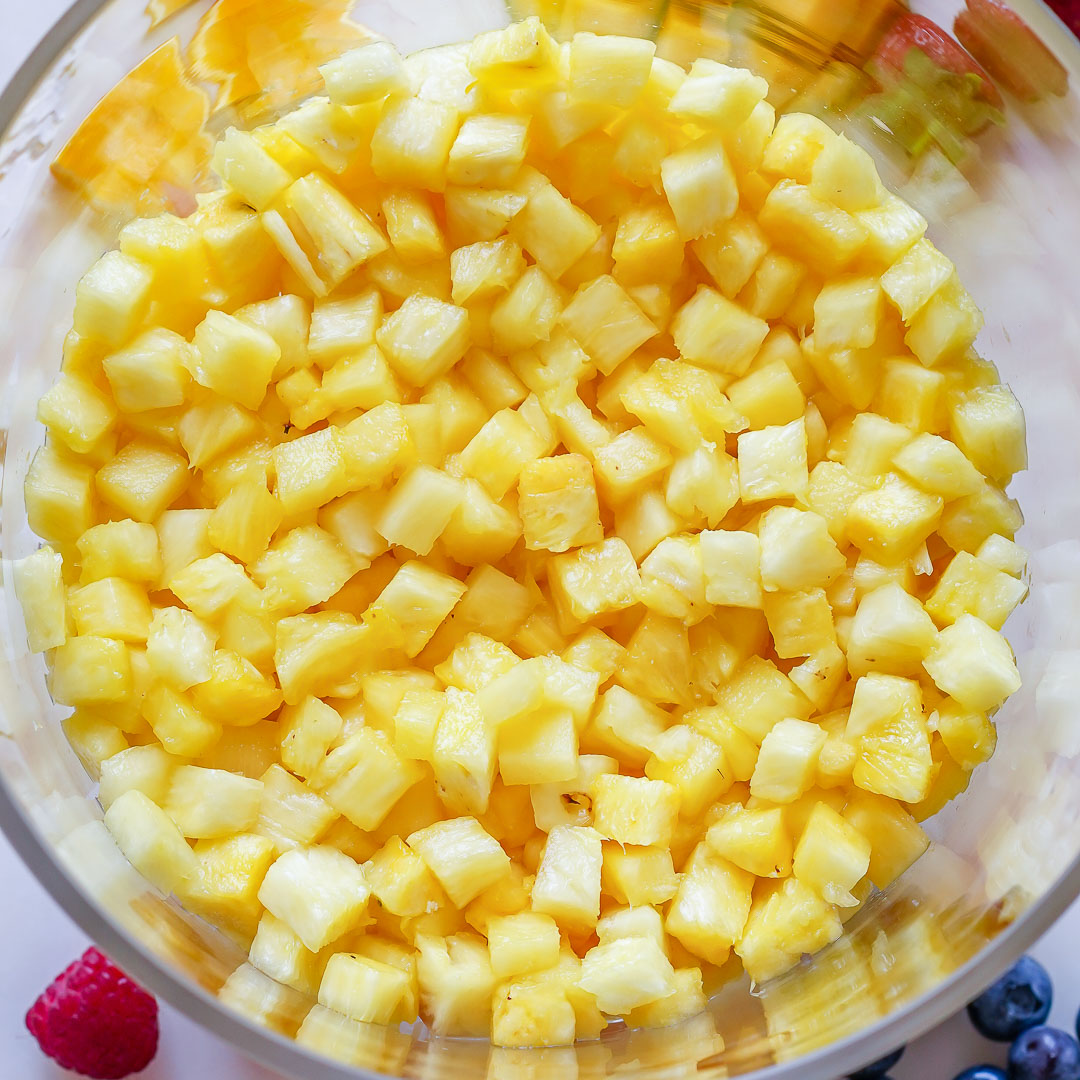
[0,0,1080,1080]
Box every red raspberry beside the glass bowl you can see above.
[26,948,158,1080]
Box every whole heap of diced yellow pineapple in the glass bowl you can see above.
[15,19,1026,1045]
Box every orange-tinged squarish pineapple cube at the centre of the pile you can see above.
[517,454,604,552]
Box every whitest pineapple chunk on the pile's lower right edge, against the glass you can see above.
[923,613,1021,712]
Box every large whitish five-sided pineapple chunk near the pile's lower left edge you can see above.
[259,847,370,953]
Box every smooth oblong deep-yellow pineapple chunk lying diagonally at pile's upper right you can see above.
[758,180,866,276]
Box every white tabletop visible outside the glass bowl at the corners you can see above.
[0,6,1080,1080]
